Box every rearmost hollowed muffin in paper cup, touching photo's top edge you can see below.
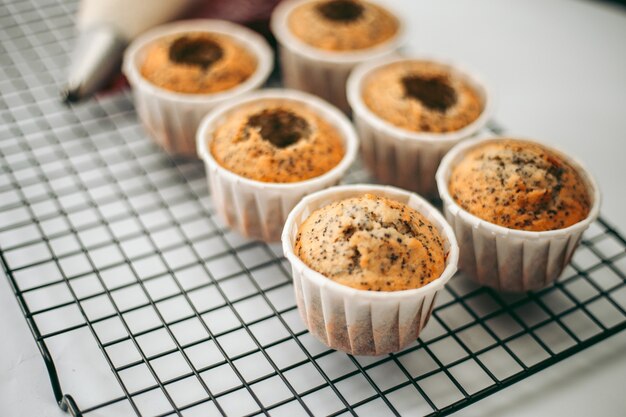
[271,0,403,111]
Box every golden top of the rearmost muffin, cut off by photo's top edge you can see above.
[287,0,399,51]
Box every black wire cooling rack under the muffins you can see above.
[0,0,626,416]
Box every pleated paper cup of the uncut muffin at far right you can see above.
[437,138,600,292]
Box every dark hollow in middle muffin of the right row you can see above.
[401,75,457,113]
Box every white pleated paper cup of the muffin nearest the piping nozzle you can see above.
[123,19,274,157]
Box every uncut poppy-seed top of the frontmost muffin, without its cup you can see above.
[295,194,446,291]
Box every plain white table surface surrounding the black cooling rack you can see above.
[0,0,626,417]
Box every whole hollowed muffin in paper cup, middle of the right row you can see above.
[347,54,492,196]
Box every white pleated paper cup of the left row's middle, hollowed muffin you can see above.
[197,89,359,242]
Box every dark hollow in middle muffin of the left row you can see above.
[247,109,311,148]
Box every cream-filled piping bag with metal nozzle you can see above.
[61,0,196,103]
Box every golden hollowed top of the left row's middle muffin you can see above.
[211,99,344,183]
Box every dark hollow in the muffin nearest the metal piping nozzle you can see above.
[169,36,224,70]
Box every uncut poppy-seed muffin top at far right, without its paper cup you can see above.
[449,139,591,231]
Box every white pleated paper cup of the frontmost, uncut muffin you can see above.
[282,185,459,355]
